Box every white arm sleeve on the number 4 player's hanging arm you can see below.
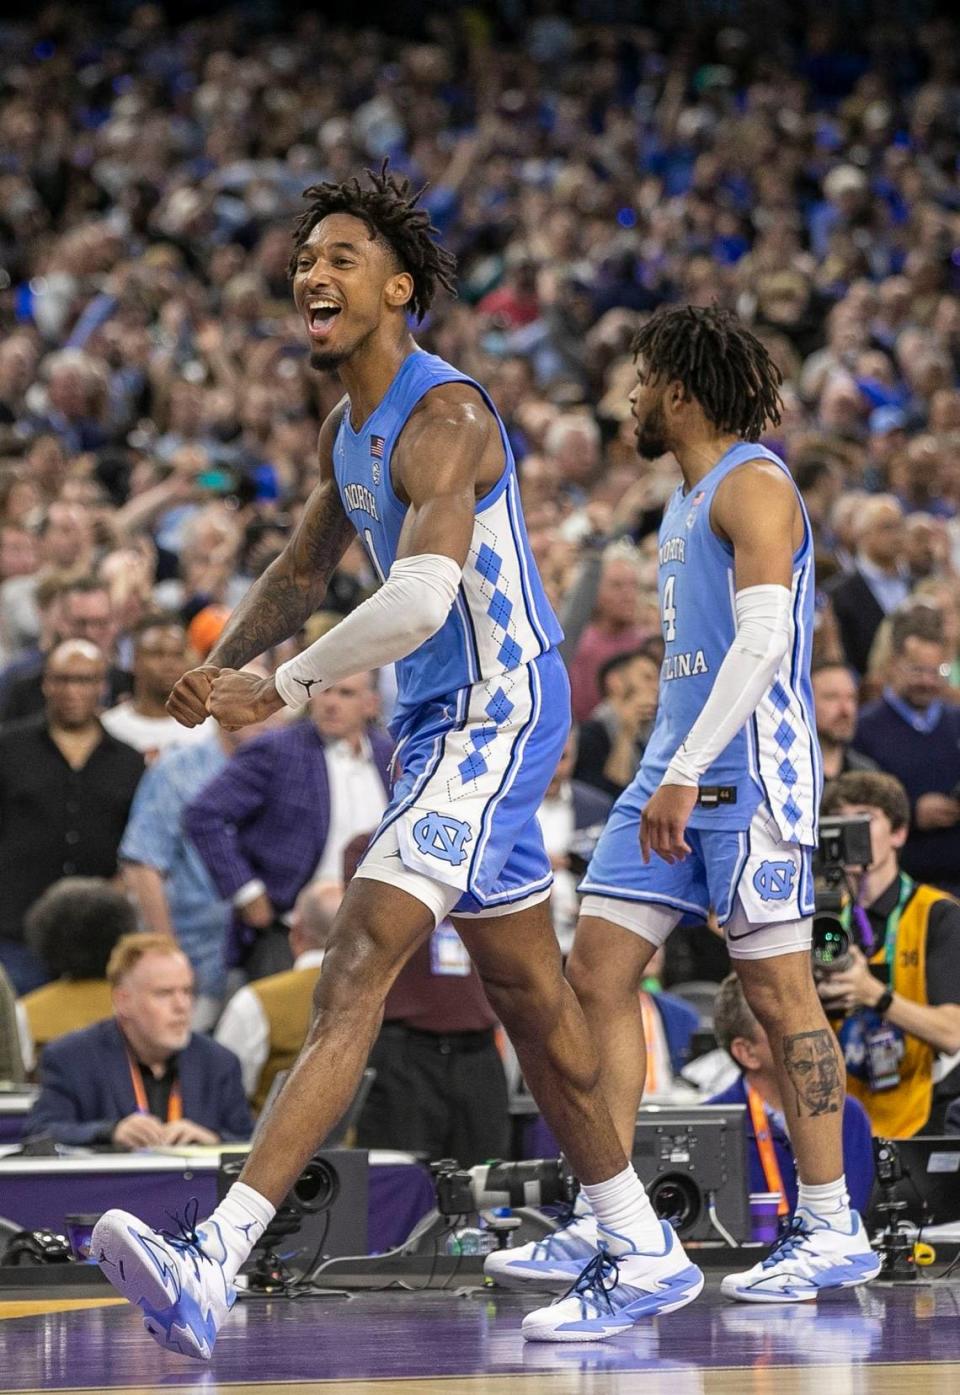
[663,586,791,785]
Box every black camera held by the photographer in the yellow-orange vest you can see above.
[813,813,873,978]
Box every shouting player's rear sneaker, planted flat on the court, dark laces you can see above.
[522,1221,703,1342]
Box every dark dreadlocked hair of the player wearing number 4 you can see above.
[632,306,783,441]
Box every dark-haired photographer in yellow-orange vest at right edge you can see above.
[819,771,960,1138]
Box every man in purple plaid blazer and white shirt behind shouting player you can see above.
[184,674,392,978]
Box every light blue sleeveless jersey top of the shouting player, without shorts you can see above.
[333,350,562,731]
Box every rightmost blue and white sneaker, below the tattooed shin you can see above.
[720,1208,880,1303]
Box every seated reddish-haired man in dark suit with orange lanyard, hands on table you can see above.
[28,935,251,1149]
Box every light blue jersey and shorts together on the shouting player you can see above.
[341,350,569,922]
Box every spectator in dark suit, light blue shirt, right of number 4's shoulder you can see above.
[827,494,910,674]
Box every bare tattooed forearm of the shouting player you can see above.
[208,487,354,668]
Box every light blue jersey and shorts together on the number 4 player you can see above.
[580,441,823,931]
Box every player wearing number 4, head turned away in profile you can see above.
[499,306,879,1324]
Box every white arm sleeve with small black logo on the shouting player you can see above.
[273,552,462,707]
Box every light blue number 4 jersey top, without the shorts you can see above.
[640,441,822,847]
